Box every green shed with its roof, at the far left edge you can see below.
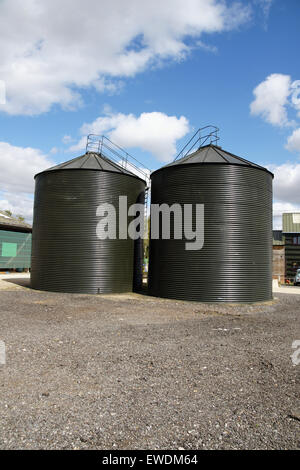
[0,212,32,270]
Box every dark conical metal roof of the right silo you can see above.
[152,144,273,176]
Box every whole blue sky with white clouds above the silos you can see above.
[0,0,300,227]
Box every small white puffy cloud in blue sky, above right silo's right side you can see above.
[250,73,291,126]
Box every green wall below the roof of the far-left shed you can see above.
[0,230,31,269]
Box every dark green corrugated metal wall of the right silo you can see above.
[149,164,272,302]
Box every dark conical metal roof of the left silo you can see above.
[35,152,141,179]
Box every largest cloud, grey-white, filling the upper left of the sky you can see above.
[0,0,251,115]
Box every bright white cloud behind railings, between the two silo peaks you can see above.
[70,111,189,161]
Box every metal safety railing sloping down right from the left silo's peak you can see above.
[86,134,151,187]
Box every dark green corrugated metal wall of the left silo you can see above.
[31,170,145,294]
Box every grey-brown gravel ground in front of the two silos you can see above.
[0,283,300,449]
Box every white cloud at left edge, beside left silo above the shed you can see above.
[0,142,54,221]
